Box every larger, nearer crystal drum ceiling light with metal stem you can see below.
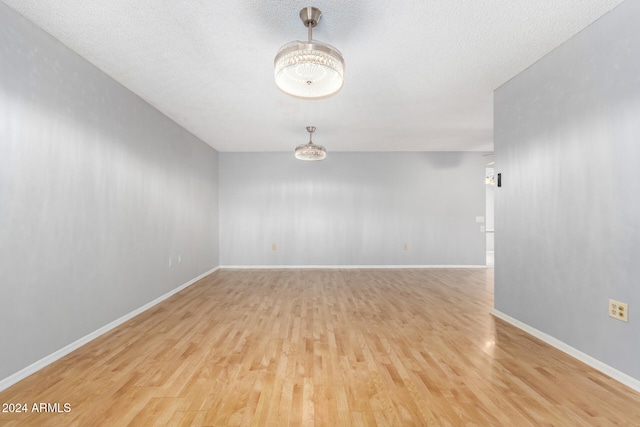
[273,6,344,99]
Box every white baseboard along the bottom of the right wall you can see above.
[491,309,640,392]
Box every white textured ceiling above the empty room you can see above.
[2,0,633,152]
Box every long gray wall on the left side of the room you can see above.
[0,2,219,379]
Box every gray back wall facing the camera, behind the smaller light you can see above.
[219,152,486,266]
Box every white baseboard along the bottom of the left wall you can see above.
[0,267,220,391]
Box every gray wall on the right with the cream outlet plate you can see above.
[495,1,640,379]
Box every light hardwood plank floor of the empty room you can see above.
[0,269,640,426]
